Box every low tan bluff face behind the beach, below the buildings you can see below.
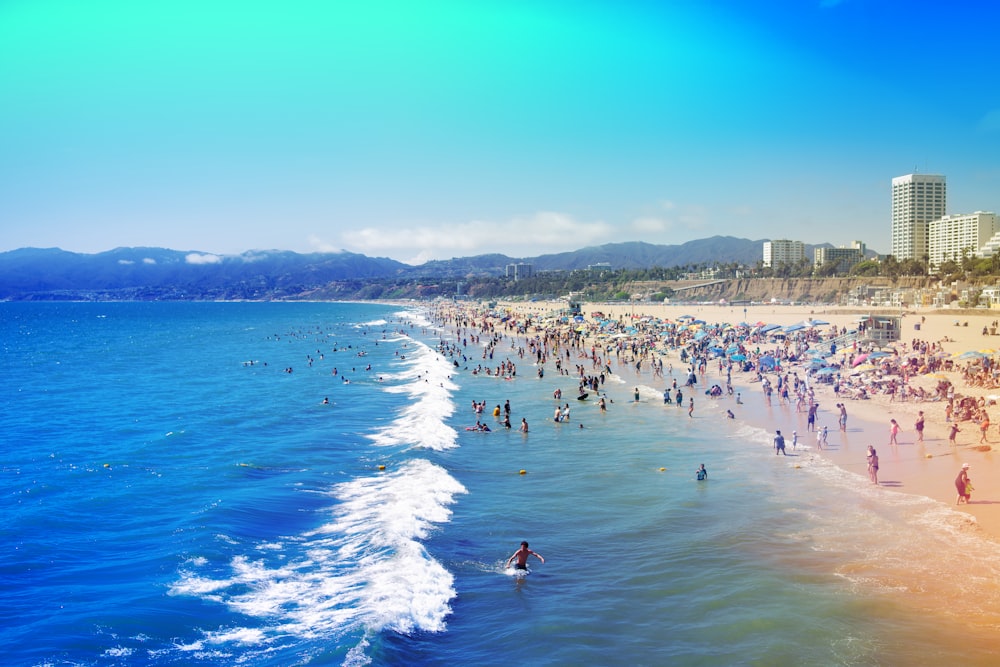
[674,277,931,303]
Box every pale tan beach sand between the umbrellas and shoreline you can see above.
[498,302,1000,539]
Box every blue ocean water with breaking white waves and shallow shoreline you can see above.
[0,303,1000,665]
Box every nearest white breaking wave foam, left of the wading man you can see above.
[170,460,465,652]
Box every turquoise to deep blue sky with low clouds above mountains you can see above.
[0,0,1000,264]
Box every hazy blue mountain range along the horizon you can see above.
[0,236,844,300]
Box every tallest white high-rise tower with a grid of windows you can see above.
[892,174,947,261]
